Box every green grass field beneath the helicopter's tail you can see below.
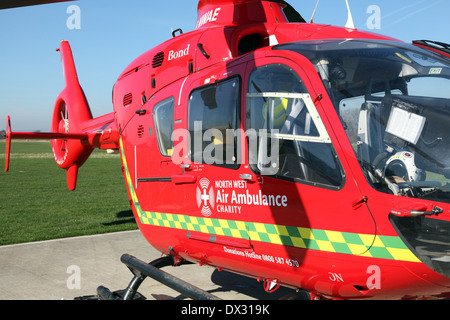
[0,140,137,245]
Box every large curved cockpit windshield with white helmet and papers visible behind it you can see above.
[274,40,450,203]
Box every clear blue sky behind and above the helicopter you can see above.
[0,0,450,131]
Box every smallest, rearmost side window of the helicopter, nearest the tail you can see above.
[153,97,175,157]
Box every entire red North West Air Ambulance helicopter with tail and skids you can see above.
[2,0,450,299]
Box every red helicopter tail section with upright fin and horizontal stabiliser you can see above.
[5,41,119,190]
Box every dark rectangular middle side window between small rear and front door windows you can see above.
[188,77,240,168]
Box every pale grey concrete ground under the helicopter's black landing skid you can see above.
[0,230,293,300]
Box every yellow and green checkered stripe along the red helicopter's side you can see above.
[122,138,420,262]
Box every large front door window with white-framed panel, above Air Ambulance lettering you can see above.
[246,64,343,187]
